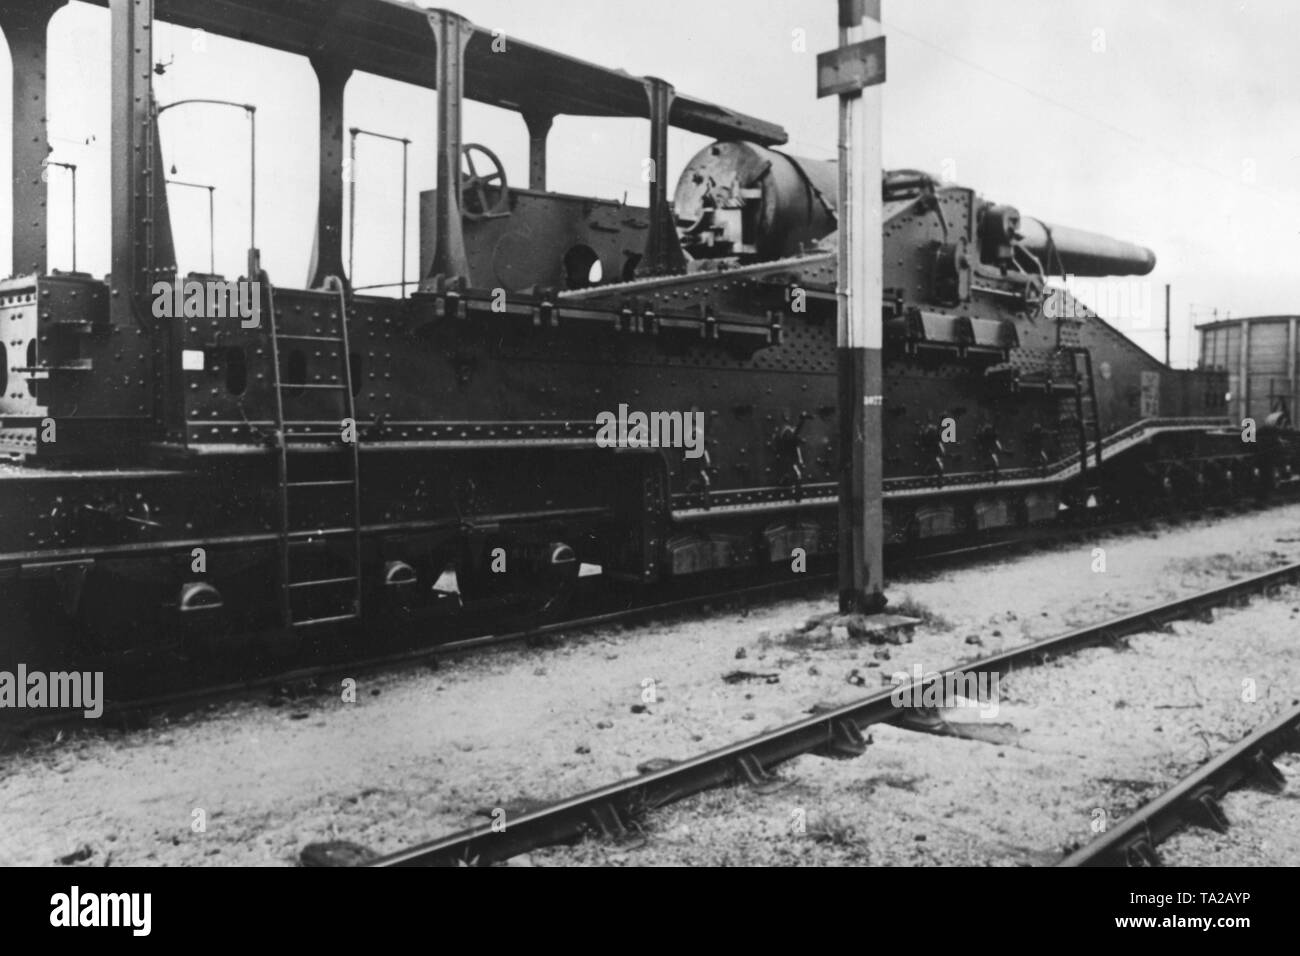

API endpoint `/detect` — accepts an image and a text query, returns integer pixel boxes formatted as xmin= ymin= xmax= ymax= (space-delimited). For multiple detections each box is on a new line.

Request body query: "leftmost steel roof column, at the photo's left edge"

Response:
xmin=0 ymin=0 xmax=66 ymax=276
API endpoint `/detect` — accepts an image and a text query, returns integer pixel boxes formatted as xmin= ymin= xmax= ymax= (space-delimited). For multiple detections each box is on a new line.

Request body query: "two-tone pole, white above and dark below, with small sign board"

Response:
xmin=818 ymin=0 xmax=885 ymax=614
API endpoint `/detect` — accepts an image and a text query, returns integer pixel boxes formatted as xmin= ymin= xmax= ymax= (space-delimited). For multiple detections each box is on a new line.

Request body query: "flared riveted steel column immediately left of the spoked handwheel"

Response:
xmin=428 ymin=10 xmax=473 ymax=281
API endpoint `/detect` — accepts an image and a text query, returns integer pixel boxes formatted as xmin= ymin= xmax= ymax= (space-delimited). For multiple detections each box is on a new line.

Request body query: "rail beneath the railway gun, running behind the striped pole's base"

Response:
xmin=0 ymin=494 xmax=1300 ymax=747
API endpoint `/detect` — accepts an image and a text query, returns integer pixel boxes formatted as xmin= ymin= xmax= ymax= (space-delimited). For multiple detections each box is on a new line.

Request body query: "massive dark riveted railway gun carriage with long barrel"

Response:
xmin=0 ymin=0 xmax=1291 ymax=661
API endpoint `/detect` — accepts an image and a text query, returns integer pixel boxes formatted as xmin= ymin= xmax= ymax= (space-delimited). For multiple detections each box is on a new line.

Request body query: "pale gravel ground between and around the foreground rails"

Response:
xmin=0 ymin=506 xmax=1300 ymax=866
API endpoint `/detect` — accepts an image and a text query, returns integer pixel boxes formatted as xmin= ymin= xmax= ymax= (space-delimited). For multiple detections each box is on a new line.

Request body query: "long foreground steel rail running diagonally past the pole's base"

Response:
xmin=372 ymin=563 xmax=1300 ymax=866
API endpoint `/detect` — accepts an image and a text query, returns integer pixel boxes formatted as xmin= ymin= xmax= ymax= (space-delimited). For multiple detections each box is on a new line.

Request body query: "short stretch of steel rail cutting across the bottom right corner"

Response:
xmin=1057 ymin=706 xmax=1300 ymax=866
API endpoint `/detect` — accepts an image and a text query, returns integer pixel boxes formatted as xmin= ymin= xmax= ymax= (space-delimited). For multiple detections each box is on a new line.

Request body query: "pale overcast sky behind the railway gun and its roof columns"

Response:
xmin=0 ymin=0 xmax=1300 ymax=365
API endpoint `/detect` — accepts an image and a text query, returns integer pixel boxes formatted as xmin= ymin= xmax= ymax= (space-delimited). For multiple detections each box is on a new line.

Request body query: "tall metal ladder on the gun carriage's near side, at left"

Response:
xmin=264 ymin=276 xmax=361 ymax=628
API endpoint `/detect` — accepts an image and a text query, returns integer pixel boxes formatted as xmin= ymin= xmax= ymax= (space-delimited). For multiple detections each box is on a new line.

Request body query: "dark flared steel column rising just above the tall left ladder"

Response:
xmin=307 ymin=56 xmax=352 ymax=289
